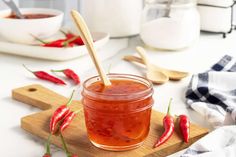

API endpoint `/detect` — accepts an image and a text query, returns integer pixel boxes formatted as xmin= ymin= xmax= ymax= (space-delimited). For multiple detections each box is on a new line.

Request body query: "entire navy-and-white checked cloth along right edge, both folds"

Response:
xmin=181 ymin=55 xmax=236 ymax=157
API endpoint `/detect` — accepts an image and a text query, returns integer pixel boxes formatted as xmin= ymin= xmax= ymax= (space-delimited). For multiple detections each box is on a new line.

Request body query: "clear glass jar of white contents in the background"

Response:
xmin=140 ymin=0 xmax=200 ymax=50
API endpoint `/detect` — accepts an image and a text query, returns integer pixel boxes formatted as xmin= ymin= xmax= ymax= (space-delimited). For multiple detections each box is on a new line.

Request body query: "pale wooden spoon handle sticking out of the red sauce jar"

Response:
xmin=71 ymin=10 xmax=111 ymax=86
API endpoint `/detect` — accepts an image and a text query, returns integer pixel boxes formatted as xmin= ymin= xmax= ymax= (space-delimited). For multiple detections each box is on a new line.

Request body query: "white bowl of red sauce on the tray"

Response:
xmin=0 ymin=8 xmax=64 ymax=44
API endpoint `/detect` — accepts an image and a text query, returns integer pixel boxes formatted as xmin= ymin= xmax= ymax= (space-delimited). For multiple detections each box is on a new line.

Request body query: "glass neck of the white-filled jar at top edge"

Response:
xmin=145 ymin=0 xmax=197 ymax=9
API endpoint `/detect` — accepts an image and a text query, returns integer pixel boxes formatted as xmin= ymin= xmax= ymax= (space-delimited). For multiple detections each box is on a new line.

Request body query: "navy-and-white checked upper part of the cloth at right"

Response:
xmin=186 ymin=55 xmax=236 ymax=127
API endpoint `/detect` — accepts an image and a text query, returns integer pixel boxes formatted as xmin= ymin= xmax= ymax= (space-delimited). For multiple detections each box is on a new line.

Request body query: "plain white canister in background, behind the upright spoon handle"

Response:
xmin=80 ymin=0 xmax=143 ymax=37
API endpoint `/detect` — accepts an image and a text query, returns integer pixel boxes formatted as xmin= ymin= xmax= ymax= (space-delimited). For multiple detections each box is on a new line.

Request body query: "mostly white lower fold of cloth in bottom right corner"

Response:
xmin=180 ymin=125 xmax=236 ymax=157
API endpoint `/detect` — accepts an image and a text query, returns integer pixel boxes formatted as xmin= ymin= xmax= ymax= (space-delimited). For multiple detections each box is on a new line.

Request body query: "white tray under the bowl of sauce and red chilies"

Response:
xmin=0 ymin=32 xmax=109 ymax=61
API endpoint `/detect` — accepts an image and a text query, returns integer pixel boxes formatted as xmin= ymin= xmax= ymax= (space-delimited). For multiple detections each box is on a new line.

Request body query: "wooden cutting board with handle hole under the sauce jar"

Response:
xmin=12 ymin=84 xmax=208 ymax=157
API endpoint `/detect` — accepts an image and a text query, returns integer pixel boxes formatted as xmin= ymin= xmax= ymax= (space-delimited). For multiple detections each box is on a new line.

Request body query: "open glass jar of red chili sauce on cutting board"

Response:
xmin=82 ymin=74 xmax=153 ymax=151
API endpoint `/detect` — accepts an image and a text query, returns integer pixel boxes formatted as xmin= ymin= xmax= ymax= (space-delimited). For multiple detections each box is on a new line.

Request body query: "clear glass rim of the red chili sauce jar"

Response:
xmin=83 ymin=73 xmax=153 ymax=100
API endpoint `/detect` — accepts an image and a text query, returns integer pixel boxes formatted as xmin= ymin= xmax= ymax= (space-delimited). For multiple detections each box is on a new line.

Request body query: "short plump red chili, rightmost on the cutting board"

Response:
xmin=179 ymin=115 xmax=190 ymax=143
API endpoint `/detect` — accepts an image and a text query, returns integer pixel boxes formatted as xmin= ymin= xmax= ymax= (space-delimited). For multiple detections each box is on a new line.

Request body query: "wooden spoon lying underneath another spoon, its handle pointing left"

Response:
xmin=124 ymin=55 xmax=189 ymax=81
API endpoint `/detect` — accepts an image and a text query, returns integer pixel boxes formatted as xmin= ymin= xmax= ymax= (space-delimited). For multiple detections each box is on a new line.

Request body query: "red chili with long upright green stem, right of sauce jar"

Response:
xmin=153 ymin=99 xmax=174 ymax=148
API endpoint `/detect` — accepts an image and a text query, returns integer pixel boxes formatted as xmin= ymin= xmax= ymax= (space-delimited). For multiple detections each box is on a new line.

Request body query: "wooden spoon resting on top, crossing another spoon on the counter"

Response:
xmin=136 ymin=47 xmax=169 ymax=84
